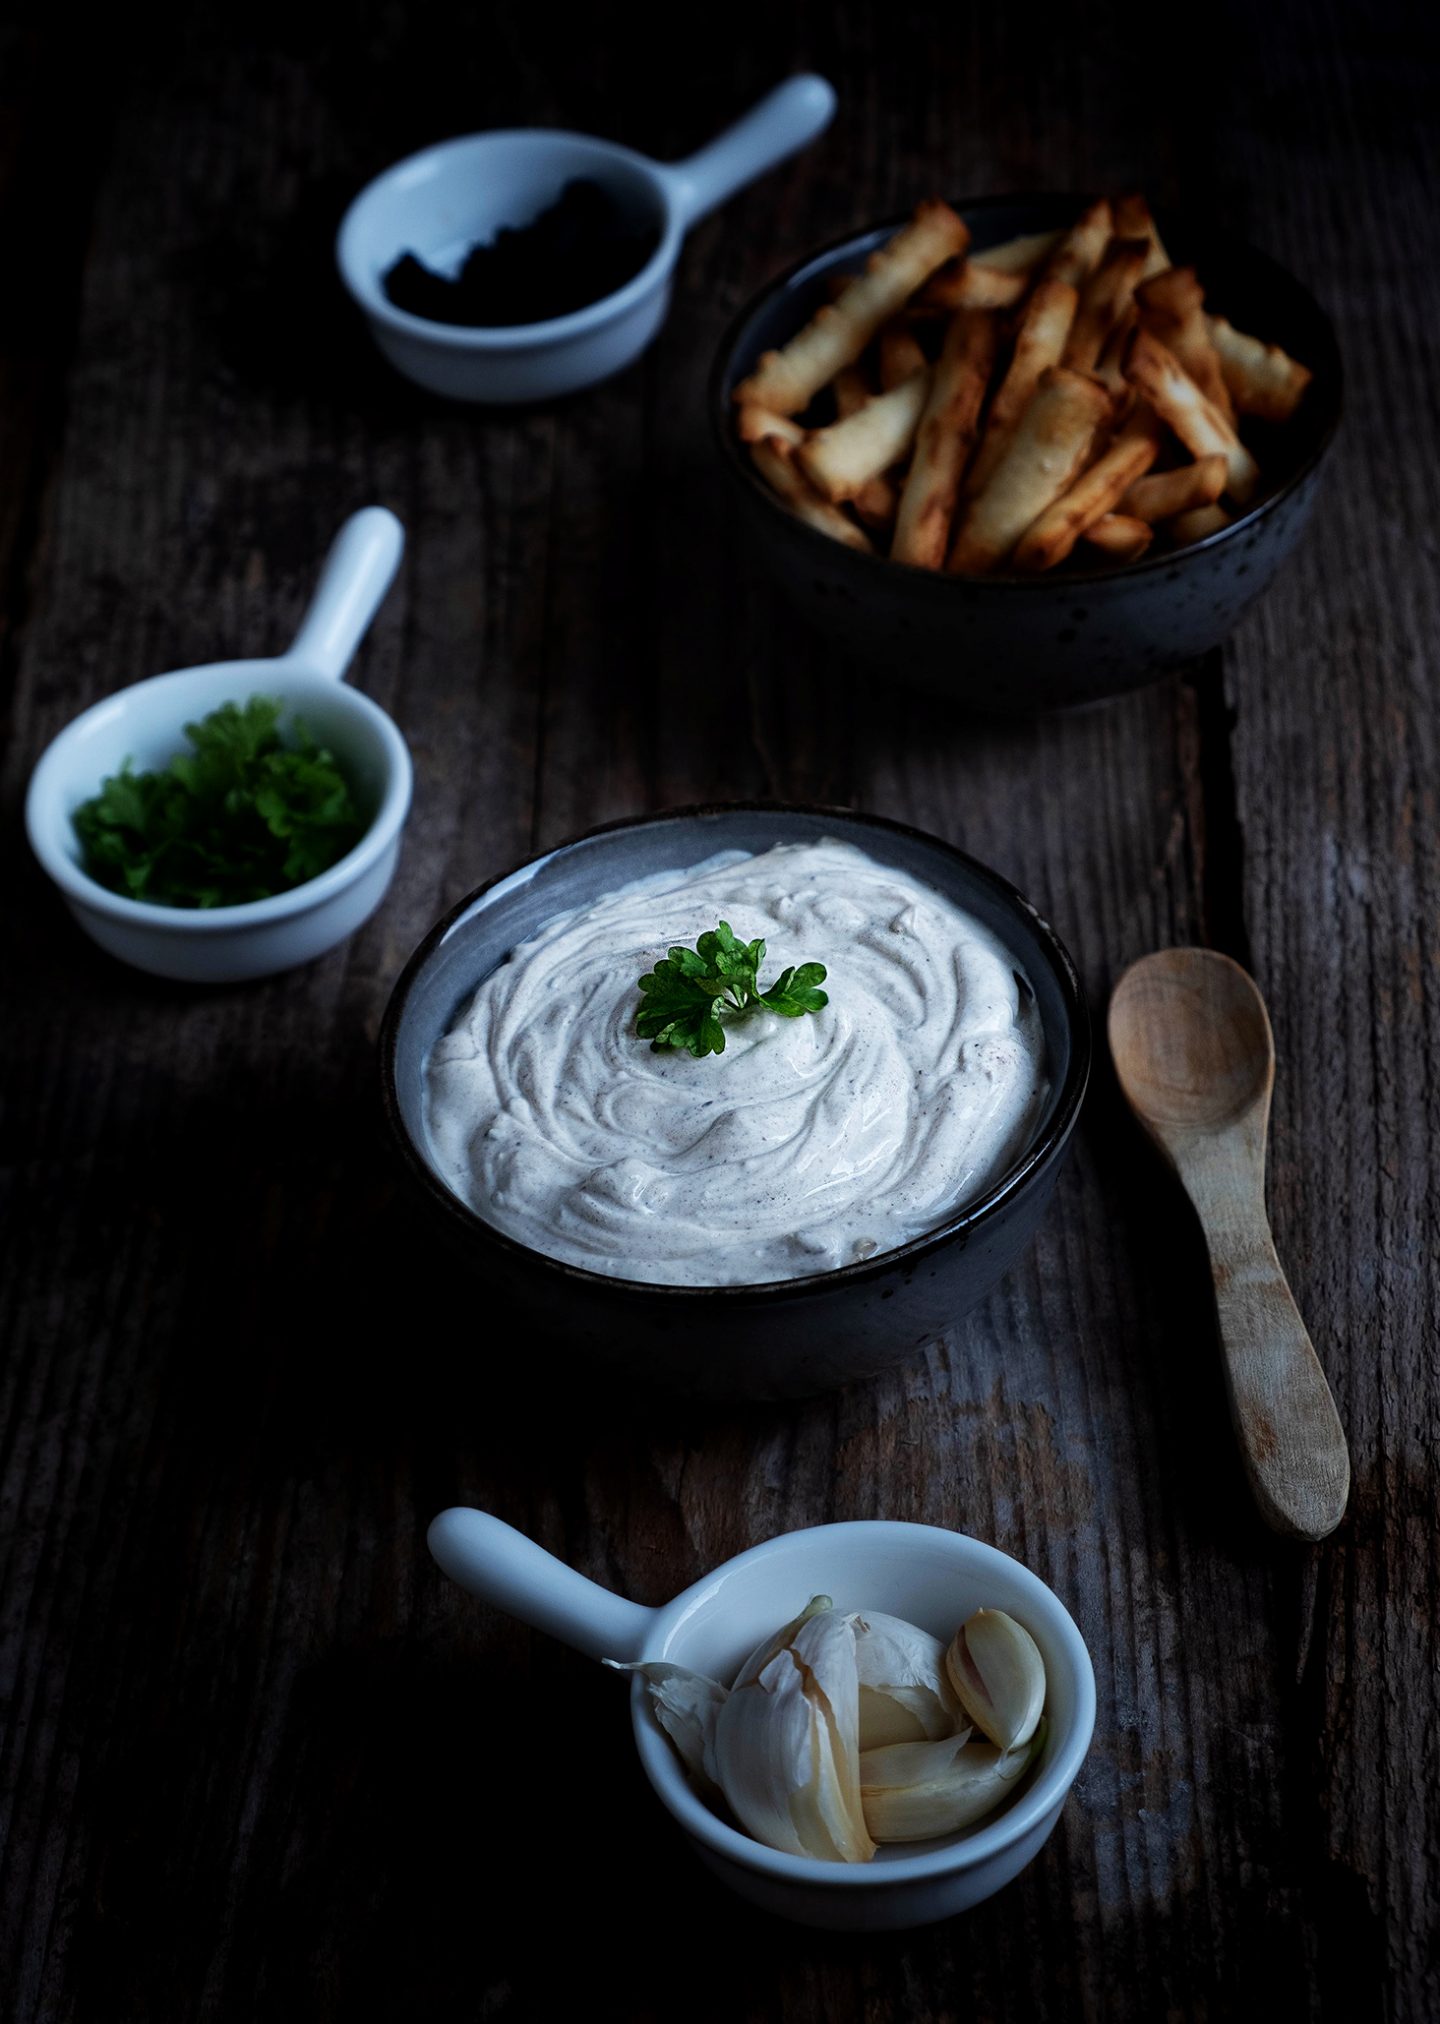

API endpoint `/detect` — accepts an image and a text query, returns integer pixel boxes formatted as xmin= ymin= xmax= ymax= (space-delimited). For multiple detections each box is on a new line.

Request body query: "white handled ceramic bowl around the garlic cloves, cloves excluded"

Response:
xmin=429 ymin=1506 xmax=1096 ymax=1931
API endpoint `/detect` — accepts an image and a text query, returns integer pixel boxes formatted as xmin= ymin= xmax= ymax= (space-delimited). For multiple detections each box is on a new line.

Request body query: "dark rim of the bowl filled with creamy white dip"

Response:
xmin=379 ymin=799 xmax=1094 ymax=1308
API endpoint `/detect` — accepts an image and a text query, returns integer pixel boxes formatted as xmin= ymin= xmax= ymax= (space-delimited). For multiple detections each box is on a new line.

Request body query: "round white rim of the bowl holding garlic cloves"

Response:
xmin=630 ymin=1518 xmax=1096 ymax=1890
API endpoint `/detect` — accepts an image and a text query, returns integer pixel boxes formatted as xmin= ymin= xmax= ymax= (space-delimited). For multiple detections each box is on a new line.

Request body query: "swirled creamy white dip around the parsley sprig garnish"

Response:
xmin=425 ymin=842 xmax=1045 ymax=1285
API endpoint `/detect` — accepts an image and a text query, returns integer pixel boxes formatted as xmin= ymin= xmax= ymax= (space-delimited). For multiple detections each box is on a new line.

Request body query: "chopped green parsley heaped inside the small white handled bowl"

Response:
xmin=75 ymin=696 xmax=367 ymax=907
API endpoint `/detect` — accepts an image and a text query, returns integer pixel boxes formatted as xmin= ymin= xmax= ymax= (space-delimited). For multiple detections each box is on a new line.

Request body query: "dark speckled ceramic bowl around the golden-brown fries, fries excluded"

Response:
xmin=709 ymin=196 xmax=1343 ymax=710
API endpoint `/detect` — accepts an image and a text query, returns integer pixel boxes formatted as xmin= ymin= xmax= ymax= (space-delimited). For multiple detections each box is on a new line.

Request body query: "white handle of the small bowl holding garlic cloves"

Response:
xmin=429 ymin=1504 xmax=658 ymax=1660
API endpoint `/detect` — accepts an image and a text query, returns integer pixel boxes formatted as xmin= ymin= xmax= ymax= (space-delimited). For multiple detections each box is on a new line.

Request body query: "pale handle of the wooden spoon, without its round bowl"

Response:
xmin=1181 ymin=1160 xmax=1351 ymax=1540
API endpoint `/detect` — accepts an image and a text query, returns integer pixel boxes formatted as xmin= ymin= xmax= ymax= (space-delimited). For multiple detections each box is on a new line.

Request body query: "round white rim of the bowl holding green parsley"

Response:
xmin=24 ymin=658 xmax=415 ymax=937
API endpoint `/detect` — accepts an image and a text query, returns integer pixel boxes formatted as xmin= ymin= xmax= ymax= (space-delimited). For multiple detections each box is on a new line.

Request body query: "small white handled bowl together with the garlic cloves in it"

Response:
xmin=429 ymin=1508 xmax=1096 ymax=1931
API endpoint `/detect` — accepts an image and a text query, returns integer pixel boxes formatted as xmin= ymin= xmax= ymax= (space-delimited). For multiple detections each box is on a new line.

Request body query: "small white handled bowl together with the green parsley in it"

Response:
xmin=26 ymin=506 xmax=411 ymax=984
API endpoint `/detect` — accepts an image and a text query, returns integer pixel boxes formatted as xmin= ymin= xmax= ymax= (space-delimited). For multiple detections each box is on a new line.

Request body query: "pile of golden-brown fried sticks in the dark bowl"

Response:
xmin=735 ymin=194 xmax=1310 ymax=577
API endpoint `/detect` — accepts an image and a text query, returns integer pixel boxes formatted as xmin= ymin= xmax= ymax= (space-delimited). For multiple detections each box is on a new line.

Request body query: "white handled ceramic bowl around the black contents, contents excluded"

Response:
xmin=336 ymin=75 xmax=834 ymax=405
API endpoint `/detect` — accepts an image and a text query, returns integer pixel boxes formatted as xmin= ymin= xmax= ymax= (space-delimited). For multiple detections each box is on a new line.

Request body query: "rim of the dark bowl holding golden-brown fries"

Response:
xmin=705 ymin=190 xmax=1345 ymax=597
